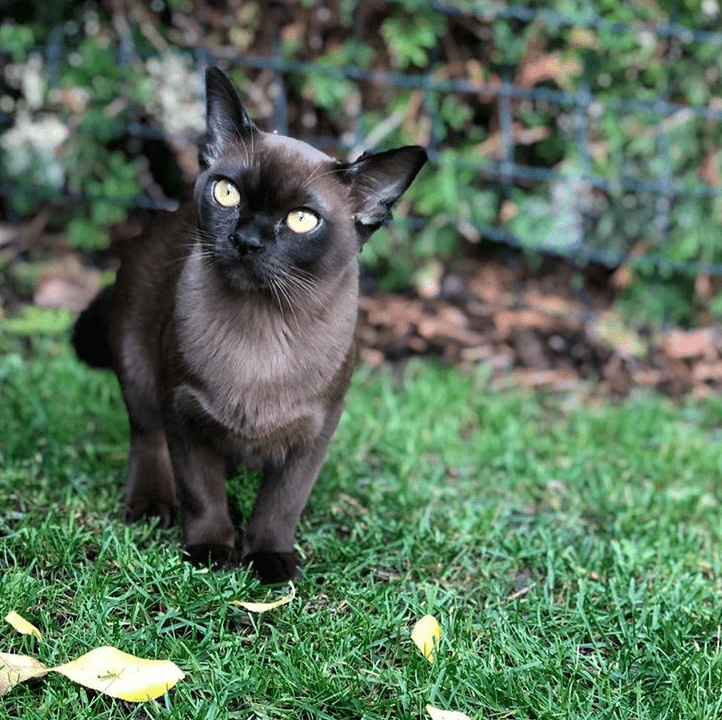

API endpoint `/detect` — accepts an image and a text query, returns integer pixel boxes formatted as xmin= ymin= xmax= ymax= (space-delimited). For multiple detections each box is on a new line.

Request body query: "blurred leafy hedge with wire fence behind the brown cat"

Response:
xmin=0 ymin=0 xmax=722 ymax=325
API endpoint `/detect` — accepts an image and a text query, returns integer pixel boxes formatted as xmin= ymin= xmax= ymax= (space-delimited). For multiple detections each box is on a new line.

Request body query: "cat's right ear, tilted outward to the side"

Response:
xmin=342 ymin=145 xmax=427 ymax=242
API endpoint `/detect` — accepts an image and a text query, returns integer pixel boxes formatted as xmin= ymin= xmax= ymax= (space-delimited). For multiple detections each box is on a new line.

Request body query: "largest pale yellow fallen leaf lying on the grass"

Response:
xmin=53 ymin=647 xmax=185 ymax=702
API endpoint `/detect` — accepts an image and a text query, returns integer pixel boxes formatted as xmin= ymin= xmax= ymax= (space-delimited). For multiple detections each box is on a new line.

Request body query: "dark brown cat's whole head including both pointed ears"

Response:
xmin=195 ymin=68 xmax=426 ymax=299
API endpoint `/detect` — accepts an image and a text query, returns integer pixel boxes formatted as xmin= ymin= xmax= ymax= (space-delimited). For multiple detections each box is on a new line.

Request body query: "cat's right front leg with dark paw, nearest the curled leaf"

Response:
xmin=241 ymin=405 xmax=342 ymax=583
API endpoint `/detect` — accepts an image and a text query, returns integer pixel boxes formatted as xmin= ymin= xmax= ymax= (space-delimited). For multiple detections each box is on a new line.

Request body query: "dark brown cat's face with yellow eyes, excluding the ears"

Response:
xmin=196 ymin=130 xmax=358 ymax=291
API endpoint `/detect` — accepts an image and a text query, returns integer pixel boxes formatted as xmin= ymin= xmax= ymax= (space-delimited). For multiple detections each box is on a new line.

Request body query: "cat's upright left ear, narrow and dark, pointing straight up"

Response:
xmin=199 ymin=67 xmax=256 ymax=167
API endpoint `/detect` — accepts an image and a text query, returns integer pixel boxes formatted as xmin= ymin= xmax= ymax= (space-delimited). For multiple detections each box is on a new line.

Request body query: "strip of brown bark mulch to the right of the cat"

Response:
xmin=360 ymin=260 xmax=722 ymax=398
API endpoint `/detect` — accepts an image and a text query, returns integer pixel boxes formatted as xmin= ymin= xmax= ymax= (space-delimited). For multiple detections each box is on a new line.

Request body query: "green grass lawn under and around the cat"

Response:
xmin=0 ymin=341 xmax=722 ymax=720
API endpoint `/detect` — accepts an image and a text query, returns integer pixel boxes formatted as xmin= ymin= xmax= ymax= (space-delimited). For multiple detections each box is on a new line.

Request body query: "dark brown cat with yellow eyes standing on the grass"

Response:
xmin=72 ymin=68 xmax=427 ymax=583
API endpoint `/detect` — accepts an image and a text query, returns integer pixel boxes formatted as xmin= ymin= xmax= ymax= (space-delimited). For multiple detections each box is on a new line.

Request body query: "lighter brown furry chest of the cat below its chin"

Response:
xmin=175 ymin=253 xmax=356 ymax=442
